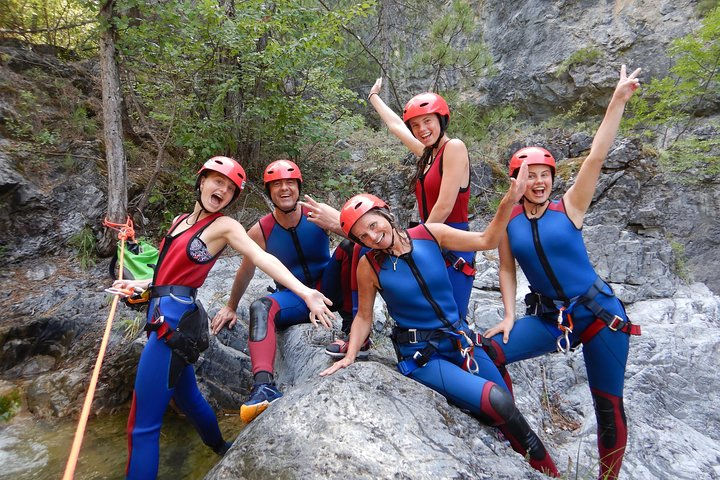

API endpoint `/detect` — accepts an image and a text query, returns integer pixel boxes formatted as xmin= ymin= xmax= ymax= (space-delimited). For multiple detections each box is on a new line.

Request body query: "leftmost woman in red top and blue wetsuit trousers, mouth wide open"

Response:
xmin=113 ymin=157 xmax=332 ymax=480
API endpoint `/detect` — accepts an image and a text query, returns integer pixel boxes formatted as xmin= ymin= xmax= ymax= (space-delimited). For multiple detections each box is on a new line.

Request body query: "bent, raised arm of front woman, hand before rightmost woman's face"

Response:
xmin=426 ymin=162 xmax=528 ymax=252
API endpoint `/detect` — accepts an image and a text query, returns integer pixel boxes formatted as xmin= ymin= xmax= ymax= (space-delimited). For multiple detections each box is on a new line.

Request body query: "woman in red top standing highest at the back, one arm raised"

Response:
xmin=368 ymin=78 xmax=475 ymax=318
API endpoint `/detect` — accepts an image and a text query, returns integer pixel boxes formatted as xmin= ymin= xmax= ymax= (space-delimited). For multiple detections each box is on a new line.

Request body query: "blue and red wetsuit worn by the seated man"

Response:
xmin=248 ymin=210 xmax=352 ymax=374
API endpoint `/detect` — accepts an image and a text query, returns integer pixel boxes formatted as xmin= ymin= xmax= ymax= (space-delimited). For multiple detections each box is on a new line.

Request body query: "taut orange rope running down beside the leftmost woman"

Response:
xmin=63 ymin=217 xmax=135 ymax=480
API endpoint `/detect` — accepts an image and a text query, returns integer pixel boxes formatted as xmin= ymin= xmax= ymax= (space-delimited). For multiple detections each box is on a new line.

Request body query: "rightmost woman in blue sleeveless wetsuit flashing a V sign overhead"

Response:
xmin=484 ymin=65 xmax=640 ymax=479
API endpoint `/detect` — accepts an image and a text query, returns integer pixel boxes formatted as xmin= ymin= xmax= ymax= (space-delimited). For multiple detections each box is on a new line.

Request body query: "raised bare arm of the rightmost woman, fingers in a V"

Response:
xmin=563 ymin=65 xmax=640 ymax=228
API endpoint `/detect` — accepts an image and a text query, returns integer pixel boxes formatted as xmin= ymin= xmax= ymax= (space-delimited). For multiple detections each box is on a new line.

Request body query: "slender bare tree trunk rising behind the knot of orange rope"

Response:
xmin=98 ymin=0 xmax=127 ymax=255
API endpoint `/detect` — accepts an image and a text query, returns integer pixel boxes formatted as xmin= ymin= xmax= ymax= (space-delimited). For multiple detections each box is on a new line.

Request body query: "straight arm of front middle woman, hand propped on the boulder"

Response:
xmin=320 ymin=257 xmax=378 ymax=377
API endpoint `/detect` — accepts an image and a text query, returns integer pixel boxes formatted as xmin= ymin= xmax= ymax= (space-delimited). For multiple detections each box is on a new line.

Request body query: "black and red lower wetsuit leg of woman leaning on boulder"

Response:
xmin=480 ymin=382 xmax=560 ymax=477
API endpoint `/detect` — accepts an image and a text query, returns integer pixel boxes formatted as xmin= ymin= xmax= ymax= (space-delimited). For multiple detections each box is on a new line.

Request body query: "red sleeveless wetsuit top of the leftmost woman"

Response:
xmin=153 ymin=212 xmax=225 ymax=288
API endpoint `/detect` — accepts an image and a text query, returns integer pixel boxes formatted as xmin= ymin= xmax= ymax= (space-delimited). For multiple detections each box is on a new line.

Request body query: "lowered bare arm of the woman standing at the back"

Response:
xmin=425 ymin=139 xmax=470 ymax=223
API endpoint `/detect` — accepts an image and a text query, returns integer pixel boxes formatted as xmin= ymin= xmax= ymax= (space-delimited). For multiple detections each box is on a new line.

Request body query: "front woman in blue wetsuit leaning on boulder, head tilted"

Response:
xmin=320 ymin=176 xmax=558 ymax=476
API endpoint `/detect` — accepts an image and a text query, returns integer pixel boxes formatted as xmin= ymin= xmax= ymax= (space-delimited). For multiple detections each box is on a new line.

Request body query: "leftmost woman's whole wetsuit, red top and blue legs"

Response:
xmin=125 ymin=213 xmax=227 ymax=480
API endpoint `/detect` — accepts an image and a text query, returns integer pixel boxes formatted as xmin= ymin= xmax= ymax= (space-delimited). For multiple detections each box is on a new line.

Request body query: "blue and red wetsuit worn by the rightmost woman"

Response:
xmin=492 ymin=200 xmax=629 ymax=478
